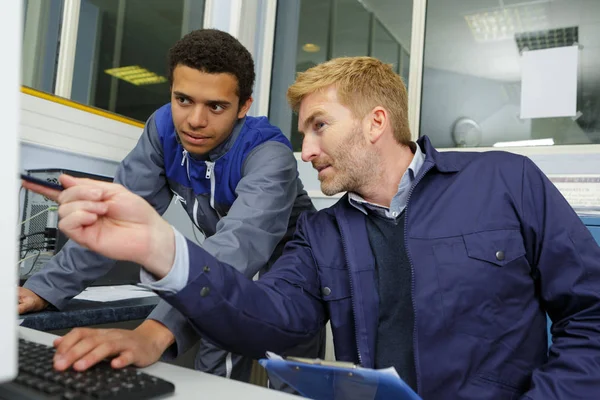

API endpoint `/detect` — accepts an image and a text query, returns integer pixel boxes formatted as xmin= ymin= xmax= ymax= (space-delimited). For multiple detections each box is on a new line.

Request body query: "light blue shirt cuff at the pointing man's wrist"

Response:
xmin=139 ymin=227 xmax=190 ymax=294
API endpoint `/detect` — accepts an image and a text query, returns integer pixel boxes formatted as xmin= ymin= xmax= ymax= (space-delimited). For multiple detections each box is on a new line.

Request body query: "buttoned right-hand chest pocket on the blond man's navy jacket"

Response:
xmin=433 ymin=230 xmax=533 ymax=339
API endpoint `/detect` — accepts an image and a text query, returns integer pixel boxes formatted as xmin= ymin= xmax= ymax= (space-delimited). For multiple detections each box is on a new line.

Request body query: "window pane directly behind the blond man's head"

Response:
xmin=269 ymin=0 xmax=412 ymax=151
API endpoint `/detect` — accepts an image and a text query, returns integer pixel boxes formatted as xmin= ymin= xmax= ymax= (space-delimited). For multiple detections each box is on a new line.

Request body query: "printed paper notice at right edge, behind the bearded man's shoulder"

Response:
xmin=548 ymin=175 xmax=600 ymax=214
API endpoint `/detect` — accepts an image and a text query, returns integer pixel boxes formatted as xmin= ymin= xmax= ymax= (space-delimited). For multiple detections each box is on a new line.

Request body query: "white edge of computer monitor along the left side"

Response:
xmin=0 ymin=1 xmax=23 ymax=382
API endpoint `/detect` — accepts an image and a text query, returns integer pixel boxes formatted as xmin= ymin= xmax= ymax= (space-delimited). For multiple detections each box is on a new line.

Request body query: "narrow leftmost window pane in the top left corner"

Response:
xmin=21 ymin=0 xmax=63 ymax=93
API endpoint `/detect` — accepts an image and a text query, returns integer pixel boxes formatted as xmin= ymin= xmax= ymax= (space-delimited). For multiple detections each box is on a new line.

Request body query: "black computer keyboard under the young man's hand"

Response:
xmin=0 ymin=339 xmax=175 ymax=400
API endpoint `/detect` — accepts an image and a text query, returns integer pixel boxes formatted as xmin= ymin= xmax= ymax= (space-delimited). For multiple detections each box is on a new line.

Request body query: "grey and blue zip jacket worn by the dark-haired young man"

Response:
xmin=24 ymin=104 xmax=314 ymax=375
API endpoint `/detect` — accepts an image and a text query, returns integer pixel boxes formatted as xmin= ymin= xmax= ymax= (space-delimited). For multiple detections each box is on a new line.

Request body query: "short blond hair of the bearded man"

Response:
xmin=287 ymin=57 xmax=411 ymax=144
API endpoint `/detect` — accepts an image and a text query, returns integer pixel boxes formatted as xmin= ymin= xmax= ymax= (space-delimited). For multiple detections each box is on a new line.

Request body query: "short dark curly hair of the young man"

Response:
xmin=167 ymin=29 xmax=255 ymax=105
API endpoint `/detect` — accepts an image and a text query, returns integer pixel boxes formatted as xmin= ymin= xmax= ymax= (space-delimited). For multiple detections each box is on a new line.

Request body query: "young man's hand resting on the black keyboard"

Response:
xmin=54 ymin=320 xmax=174 ymax=371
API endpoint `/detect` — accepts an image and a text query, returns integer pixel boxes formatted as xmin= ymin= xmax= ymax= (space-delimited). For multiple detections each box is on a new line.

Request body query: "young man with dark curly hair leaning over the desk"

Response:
xmin=19 ymin=29 xmax=324 ymax=388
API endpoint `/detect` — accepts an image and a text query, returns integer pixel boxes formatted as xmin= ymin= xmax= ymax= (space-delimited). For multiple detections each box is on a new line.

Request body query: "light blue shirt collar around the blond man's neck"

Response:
xmin=348 ymin=145 xmax=425 ymax=220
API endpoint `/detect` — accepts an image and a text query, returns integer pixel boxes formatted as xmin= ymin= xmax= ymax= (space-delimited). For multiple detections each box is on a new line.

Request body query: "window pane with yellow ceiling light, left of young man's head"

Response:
xmin=71 ymin=0 xmax=204 ymax=121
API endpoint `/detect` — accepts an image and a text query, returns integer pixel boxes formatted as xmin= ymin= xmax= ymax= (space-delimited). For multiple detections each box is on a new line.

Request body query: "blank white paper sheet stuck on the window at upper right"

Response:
xmin=521 ymin=46 xmax=579 ymax=118
